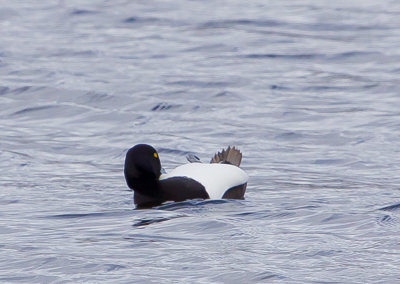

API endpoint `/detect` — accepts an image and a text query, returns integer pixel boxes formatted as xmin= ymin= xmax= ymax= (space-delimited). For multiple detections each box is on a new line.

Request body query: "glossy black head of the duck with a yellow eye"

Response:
xmin=124 ymin=144 xmax=161 ymax=196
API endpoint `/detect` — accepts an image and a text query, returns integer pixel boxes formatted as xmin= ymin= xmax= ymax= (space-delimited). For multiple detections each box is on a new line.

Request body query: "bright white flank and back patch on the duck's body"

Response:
xmin=160 ymin=163 xmax=249 ymax=199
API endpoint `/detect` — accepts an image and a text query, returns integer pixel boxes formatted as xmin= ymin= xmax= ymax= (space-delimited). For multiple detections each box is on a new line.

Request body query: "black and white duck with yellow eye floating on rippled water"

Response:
xmin=124 ymin=144 xmax=248 ymax=209
